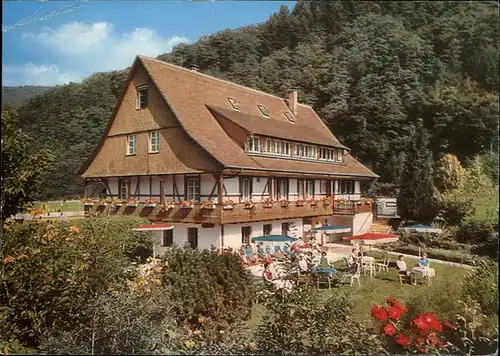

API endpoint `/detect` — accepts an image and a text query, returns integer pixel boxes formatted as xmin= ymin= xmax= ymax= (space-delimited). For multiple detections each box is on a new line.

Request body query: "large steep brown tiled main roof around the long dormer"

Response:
xmin=86 ymin=56 xmax=376 ymax=177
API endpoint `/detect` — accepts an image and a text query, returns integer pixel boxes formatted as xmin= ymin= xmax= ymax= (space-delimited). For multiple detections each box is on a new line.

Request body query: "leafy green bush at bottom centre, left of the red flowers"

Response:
xmin=254 ymin=285 xmax=387 ymax=355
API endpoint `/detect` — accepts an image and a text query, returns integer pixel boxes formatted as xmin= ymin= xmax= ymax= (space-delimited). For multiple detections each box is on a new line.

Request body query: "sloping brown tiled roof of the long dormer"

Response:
xmin=207 ymin=105 xmax=347 ymax=148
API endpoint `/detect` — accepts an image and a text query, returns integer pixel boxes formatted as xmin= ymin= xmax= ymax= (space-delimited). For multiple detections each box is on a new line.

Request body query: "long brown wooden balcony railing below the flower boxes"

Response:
xmin=86 ymin=201 xmax=372 ymax=224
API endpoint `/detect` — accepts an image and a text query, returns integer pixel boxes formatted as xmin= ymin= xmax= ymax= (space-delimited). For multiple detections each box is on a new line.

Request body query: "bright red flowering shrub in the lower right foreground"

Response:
xmin=371 ymin=298 xmax=456 ymax=353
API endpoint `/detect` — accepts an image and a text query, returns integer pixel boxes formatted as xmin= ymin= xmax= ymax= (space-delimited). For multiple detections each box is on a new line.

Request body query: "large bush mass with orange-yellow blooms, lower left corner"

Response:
xmin=0 ymin=216 xmax=152 ymax=347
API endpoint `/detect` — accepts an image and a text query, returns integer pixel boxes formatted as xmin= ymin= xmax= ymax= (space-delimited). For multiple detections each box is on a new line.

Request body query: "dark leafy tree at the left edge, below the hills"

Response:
xmin=0 ymin=110 xmax=54 ymax=223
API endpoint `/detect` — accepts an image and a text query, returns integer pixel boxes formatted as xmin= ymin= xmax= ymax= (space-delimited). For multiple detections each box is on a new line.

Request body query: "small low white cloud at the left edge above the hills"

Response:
xmin=2 ymin=63 xmax=82 ymax=86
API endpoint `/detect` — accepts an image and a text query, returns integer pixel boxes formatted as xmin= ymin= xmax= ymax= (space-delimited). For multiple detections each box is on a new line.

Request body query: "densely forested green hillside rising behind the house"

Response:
xmin=13 ymin=1 xmax=499 ymax=198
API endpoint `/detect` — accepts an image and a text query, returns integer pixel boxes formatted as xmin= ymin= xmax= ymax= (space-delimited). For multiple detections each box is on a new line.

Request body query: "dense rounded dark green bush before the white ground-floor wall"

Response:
xmin=162 ymin=248 xmax=255 ymax=331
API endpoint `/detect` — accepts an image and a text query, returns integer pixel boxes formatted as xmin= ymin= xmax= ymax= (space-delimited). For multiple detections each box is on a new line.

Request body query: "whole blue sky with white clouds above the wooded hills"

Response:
xmin=2 ymin=1 xmax=295 ymax=86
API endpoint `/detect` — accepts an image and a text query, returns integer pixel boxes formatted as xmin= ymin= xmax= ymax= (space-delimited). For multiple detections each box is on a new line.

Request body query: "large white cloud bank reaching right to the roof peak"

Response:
xmin=9 ymin=22 xmax=189 ymax=85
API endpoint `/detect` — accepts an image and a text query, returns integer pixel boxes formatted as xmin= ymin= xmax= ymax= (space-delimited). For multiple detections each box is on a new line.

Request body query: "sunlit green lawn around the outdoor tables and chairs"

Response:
xmin=248 ymin=252 xmax=468 ymax=329
